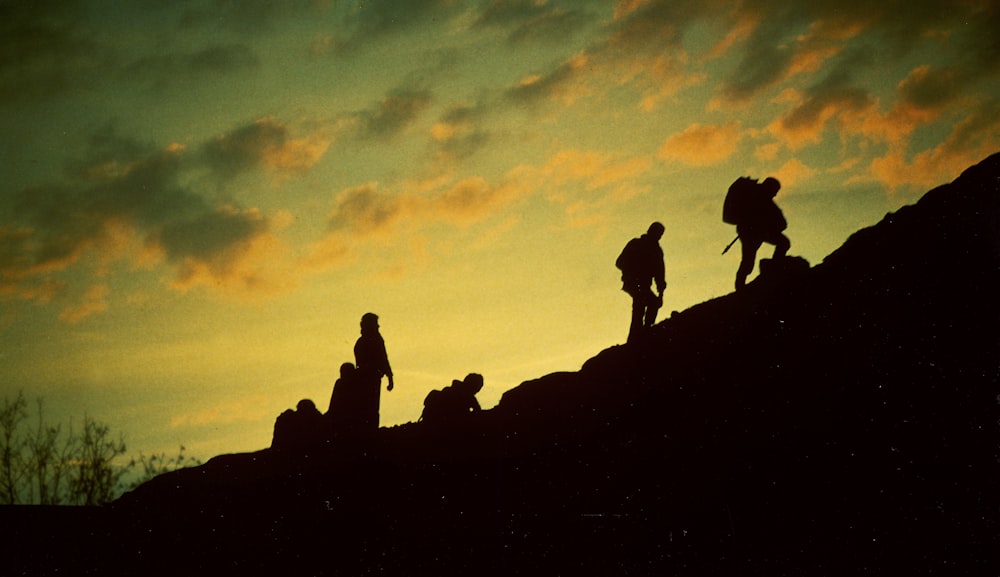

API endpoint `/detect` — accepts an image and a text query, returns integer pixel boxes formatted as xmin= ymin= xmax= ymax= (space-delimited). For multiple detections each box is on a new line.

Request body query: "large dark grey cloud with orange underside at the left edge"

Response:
xmin=0 ymin=119 xmax=316 ymax=322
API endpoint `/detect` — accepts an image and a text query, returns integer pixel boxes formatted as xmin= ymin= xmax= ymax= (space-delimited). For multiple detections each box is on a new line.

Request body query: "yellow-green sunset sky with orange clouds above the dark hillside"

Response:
xmin=0 ymin=0 xmax=1000 ymax=460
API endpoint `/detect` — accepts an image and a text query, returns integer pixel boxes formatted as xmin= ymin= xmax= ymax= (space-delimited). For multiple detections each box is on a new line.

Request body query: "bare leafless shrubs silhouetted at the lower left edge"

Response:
xmin=0 ymin=392 xmax=200 ymax=505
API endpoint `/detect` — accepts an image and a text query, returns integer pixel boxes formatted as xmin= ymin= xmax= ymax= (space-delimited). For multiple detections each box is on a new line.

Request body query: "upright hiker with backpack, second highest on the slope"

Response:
xmin=615 ymin=222 xmax=667 ymax=342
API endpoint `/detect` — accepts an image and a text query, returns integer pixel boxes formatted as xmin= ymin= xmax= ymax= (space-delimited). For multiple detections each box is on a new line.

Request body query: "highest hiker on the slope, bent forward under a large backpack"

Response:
xmin=722 ymin=176 xmax=792 ymax=290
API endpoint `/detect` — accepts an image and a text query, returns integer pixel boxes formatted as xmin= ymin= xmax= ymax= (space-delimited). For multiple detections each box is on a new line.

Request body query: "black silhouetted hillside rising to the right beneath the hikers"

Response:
xmin=9 ymin=155 xmax=1000 ymax=575
